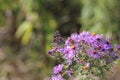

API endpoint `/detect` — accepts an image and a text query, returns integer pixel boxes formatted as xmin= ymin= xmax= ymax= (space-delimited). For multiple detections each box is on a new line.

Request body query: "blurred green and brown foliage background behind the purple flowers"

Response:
xmin=0 ymin=0 xmax=120 ymax=80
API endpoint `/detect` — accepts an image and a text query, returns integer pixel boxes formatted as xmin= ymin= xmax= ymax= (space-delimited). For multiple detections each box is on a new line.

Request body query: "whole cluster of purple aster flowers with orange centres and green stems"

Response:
xmin=48 ymin=31 xmax=120 ymax=80
